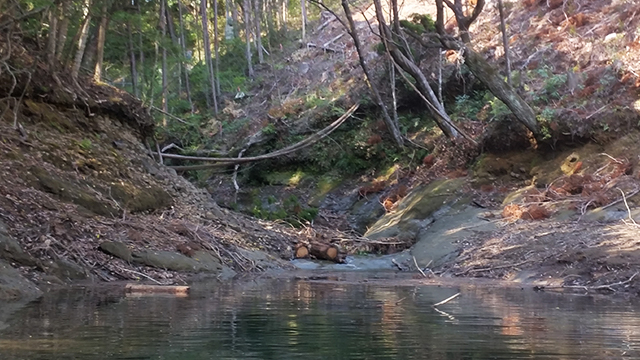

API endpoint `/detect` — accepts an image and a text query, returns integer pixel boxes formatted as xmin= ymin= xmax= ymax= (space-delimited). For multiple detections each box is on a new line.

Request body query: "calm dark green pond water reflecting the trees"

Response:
xmin=0 ymin=274 xmax=640 ymax=360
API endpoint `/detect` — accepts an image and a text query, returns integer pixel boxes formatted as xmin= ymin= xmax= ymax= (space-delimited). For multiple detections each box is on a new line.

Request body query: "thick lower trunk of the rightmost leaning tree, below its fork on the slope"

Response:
xmin=464 ymin=46 xmax=540 ymax=136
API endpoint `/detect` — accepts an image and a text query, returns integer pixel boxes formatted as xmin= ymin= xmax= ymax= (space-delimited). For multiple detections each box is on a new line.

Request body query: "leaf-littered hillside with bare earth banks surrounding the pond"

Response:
xmin=0 ymin=1 xmax=640 ymax=297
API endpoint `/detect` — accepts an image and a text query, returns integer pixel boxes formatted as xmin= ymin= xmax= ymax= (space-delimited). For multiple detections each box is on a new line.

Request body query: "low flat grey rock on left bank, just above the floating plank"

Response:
xmin=132 ymin=250 xmax=223 ymax=273
